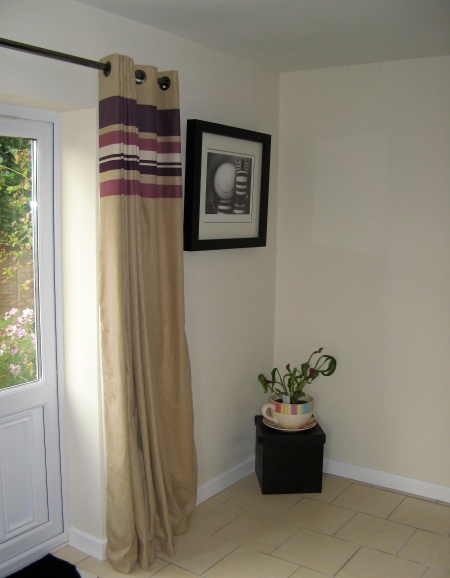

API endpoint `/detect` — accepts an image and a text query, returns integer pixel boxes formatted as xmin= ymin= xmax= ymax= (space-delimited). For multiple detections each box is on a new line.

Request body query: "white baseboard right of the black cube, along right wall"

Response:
xmin=323 ymin=458 xmax=450 ymax=502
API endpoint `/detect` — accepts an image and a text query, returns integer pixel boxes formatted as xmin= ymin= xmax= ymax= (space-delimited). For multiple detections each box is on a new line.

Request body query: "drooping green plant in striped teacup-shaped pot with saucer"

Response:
xmin=258 ymin=347 xmax=337 ymax=430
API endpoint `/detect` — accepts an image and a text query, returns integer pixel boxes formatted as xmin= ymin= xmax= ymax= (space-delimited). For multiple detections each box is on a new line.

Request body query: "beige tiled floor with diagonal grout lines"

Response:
xmin=56 ymin=474 xmax=450 ymax=578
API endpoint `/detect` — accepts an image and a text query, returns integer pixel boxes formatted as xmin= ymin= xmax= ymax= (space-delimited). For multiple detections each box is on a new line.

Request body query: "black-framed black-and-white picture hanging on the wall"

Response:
xmin=184 ymin=120 xmax=271 ymax=251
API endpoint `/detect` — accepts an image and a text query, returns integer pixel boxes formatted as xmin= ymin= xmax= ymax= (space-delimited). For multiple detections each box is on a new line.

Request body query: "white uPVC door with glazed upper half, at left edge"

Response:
xmin=0 ymin=108 xmax=64 ymax=576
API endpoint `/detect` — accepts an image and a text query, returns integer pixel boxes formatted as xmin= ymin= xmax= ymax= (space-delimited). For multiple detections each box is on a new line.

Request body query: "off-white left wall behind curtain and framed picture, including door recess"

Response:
xmin=0 ymin=0 xmax=279 ymax=548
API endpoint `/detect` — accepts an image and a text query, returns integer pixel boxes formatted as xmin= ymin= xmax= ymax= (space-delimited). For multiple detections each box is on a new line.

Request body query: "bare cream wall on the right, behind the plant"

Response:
xmin=275 ymin=58 xmax=450 ymax=495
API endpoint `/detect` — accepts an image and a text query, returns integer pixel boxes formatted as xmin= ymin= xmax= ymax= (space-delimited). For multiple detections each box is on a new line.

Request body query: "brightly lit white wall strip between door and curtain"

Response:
xmin=61 ymin=109 xmax=106 ymax=555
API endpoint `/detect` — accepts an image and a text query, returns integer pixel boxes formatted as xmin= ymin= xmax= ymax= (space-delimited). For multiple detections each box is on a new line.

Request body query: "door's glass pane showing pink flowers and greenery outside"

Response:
xmin=0 ymin=136 xmax=39 ymax=389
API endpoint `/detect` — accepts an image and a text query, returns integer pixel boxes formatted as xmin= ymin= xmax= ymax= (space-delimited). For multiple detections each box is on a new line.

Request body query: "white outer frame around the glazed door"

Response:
xmin=0 ymin=103 xmax=70 ymax=577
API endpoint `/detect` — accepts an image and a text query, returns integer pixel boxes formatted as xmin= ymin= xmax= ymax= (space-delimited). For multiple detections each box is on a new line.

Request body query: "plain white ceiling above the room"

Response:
xmin=77 ymin=0 xmax=450 ymax=72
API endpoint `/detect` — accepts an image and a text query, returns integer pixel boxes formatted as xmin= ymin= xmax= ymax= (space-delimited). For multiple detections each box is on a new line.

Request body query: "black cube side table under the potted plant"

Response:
xmin=255 ymin=415 xmax=326 ymax=494
